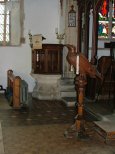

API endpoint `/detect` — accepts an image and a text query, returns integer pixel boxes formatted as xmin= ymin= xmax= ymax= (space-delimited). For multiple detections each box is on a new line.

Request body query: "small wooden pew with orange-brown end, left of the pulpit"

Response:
xmin=6 ymin=70 xmax=28 ymax=108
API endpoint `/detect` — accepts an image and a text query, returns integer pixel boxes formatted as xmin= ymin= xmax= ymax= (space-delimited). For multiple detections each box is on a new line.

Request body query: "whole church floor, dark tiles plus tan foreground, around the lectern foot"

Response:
xmin=0 ymin=95 xmax=115 ymax=154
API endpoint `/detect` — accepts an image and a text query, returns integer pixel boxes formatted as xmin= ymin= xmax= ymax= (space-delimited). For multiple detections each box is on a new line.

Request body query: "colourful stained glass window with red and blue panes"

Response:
xmin=98 ymin=0 xmax=115 ymax=38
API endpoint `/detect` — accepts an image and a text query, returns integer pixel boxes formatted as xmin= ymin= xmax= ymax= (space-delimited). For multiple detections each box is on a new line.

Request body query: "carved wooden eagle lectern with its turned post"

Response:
xmin=65 ymin=45 xmax=100 ymax=139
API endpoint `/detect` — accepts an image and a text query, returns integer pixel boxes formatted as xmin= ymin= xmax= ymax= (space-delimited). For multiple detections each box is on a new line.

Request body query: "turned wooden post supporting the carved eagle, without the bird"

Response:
xmin=75 ymin=74 xmax=87 ymax=137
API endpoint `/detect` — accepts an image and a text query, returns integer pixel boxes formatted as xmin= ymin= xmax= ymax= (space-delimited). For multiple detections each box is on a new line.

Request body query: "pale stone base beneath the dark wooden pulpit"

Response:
xmin=31 ymin=74 xmax=61 ymax=100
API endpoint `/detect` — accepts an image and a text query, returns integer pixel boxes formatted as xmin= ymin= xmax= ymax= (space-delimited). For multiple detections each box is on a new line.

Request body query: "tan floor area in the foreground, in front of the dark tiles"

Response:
xmin=3 ymin=124 xmax=115 ymax=154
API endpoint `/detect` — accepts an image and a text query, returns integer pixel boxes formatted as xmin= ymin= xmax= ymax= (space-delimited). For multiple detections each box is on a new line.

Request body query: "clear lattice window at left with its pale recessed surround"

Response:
xmin=0 ymin=0 xmax=24 ymax=46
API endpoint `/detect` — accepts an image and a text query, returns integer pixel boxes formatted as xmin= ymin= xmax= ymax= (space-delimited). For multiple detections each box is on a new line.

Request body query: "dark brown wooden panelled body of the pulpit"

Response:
xmin=32 ymin=44 xmax=63 ymax=74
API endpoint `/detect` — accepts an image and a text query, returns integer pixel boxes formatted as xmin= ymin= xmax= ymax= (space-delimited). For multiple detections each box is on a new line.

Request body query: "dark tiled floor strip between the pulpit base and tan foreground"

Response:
xmin=0 ymin=99 xmax=75 ymax=127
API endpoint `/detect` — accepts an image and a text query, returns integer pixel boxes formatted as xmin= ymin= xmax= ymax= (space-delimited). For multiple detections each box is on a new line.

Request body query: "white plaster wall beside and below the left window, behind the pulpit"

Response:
xmin=0 ymin=0 xmax=59 ymax=92
